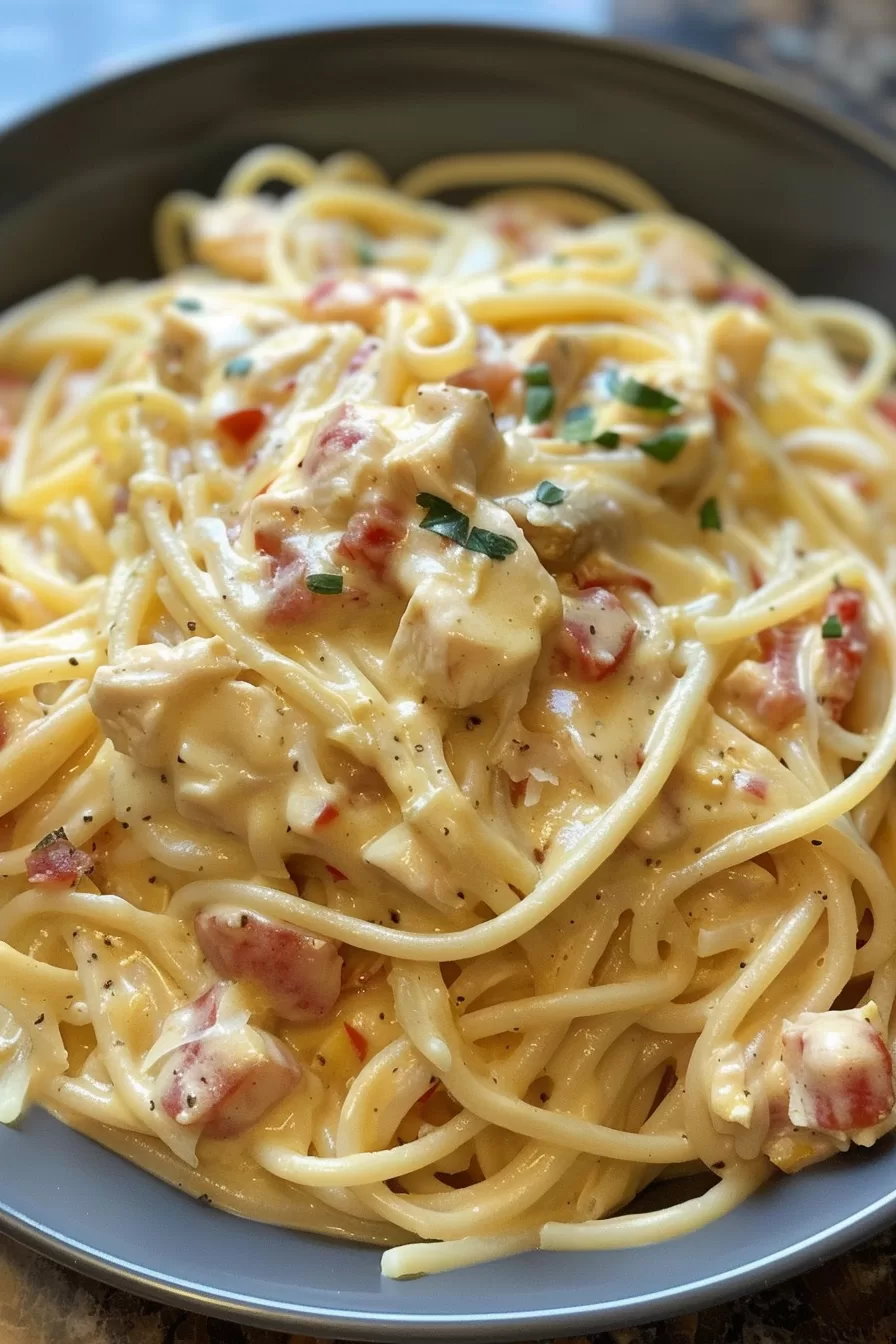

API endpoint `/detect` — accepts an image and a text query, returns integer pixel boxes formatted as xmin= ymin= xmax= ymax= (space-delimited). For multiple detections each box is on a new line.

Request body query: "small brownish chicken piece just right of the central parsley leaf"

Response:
xmin=502 ymin=481 xmax=623 ymax=569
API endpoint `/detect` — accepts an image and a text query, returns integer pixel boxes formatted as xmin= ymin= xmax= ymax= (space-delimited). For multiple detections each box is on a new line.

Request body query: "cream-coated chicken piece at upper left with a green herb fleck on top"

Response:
xmin=153 ymin=292 xmax=287 ymax=396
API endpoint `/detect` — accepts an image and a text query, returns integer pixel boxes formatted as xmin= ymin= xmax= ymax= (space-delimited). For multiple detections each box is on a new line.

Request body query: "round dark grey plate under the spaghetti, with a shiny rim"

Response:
xmin=0 ymin=27 xmax=896 ymax=1340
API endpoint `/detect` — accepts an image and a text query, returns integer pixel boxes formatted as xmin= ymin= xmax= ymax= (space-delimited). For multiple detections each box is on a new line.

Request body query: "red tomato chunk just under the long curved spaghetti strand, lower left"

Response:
xmin=195 ymin=906 xmax=343 ymax=1021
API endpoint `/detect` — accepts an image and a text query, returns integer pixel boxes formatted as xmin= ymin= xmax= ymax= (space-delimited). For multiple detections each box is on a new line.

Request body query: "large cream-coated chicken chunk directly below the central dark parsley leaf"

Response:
xmin=390 ymin=500 xmax=560 ymax=708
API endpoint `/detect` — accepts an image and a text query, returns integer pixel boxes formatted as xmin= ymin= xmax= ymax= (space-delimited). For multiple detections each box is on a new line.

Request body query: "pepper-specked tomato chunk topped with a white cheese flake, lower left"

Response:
xmin=156 ymin=981 xmax=302 ymax=1138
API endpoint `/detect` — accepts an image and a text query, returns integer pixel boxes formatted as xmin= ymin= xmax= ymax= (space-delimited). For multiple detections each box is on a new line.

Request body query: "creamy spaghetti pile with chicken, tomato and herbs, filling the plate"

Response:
xmin=0 ymin=146 xmax=896 ymax=1277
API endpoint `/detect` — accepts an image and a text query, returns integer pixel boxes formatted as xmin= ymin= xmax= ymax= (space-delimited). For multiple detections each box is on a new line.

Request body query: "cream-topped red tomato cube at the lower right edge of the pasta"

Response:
xmin=782 ymin=1005 xmax=896 ymax=1134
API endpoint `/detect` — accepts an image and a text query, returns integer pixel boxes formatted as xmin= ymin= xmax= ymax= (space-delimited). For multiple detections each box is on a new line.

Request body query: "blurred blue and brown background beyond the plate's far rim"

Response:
xmin=0 ymin=0 xmax=896 ymax=134
